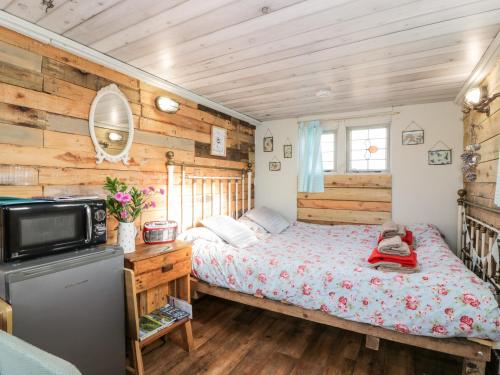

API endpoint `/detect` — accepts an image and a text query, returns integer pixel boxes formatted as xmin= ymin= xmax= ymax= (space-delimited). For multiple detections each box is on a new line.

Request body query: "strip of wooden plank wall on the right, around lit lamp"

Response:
xmin=464 ymin=59 xmax=500 ymax=228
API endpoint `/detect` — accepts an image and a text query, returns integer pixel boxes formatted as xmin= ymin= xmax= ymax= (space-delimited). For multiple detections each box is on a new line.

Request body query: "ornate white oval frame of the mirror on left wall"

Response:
xmin=89 ymin=83 xmax=134 ymax=165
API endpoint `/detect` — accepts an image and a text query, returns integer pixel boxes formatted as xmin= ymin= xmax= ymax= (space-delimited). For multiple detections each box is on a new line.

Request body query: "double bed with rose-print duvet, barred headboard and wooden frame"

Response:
xmin=167 ymin=153 xmax=500 ymax=374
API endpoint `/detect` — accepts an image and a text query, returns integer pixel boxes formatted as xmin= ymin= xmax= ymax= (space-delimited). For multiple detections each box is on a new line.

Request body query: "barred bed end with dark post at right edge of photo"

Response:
xmin=457 ymin=189 xmax=500 ymax=296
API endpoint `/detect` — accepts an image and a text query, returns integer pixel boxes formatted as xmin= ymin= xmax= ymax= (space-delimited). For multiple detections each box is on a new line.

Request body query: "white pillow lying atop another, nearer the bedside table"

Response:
xmin=201 ymin=216 xmax=258 ymax=248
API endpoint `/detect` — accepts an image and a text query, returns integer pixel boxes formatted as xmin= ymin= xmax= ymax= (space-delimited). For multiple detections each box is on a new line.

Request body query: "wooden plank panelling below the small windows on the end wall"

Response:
xmin=297 ymin=174 xmax=392 ymax=224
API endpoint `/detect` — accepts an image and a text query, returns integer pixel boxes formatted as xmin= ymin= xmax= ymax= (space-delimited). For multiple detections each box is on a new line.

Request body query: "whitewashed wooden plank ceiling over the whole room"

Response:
xmin=0 ymin=0 xmax=500 ymax=120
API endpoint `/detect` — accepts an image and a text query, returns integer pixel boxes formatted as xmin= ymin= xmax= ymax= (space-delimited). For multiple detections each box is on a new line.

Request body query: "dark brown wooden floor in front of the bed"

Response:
xmin=144 ymin=296 xmax=461 ymax=375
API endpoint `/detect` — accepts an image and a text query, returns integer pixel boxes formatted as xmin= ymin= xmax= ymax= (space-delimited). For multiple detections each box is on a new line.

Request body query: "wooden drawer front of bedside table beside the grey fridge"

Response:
xmin=135 ymin=258 xmax=191 ymax=293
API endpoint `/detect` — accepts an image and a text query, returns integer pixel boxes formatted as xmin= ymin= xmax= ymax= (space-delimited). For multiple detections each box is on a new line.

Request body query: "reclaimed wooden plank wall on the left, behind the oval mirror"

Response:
xmin=0 ymin=28 xmax=255 ymax=241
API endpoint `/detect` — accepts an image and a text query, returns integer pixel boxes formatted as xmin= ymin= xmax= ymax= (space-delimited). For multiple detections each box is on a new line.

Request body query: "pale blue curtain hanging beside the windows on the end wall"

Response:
xmin=299 ymin=120 xmax=325 ymax=193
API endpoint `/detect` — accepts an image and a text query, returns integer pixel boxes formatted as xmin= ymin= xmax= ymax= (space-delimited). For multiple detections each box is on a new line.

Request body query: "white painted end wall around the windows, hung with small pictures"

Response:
xmin=255 ymin=102 xmax=463 ymax=248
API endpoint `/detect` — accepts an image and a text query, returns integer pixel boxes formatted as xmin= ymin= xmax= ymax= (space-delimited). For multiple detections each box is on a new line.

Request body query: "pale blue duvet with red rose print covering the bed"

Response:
xmin=193 ymin=222 xmax=500 ymax=341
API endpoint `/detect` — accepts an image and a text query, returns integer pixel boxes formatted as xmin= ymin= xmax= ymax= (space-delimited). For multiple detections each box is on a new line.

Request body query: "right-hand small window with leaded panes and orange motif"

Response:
xmin=347 ymin=125 xmax=389 ymax=172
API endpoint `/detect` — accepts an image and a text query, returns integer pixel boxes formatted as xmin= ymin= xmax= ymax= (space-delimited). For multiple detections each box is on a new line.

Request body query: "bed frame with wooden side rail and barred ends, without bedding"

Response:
xmin=167 ymin=152 xmax=500 ymax=375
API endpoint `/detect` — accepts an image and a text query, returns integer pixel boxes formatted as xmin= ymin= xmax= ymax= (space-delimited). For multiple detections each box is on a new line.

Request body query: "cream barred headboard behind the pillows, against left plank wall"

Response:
xmin=167 ymin=151 xmax=253 ymax=231
